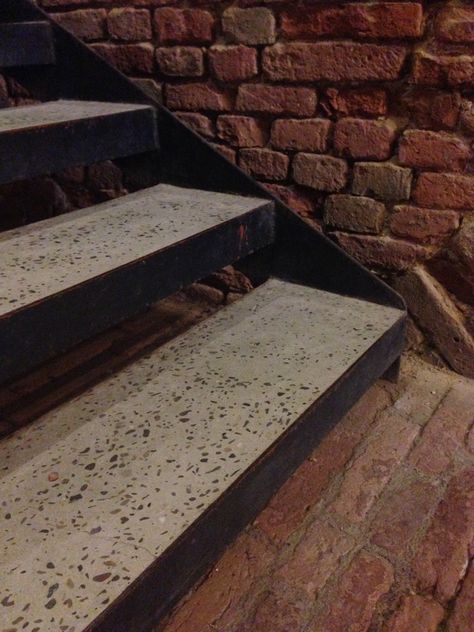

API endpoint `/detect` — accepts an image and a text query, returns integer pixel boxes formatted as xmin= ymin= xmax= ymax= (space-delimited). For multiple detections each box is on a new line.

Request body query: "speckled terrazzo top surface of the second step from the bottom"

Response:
xmin=0 ymin=184 xmax=271 ymax=318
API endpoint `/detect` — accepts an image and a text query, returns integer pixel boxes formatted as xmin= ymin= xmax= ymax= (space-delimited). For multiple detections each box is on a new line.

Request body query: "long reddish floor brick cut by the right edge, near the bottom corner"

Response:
xmin=412 ymin=468 xmax=474 ymax=604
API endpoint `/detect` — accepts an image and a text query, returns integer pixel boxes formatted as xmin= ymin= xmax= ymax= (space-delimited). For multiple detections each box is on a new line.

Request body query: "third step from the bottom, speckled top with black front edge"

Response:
xmin=0 ymin=100 xmax=158 ymax=183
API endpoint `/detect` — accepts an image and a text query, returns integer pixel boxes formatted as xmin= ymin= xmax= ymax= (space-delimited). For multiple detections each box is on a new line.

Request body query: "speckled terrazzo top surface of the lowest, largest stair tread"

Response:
xmin=0 ymin=279 xmax=403 ymax=630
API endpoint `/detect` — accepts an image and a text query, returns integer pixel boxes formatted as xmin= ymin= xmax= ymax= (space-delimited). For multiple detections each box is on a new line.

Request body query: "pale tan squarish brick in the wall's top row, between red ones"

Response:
xmin=222 ymin=7 xmax=276 ymax=45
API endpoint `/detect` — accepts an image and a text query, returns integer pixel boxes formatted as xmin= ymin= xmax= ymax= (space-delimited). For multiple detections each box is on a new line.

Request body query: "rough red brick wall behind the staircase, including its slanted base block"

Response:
xmin=42 ymin=0 xmax=474 ymax=375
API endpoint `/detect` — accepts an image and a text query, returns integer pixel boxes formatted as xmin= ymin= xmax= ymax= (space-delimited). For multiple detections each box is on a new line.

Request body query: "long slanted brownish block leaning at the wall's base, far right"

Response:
xmin=394 ymin=267 xmax=474 ymax=377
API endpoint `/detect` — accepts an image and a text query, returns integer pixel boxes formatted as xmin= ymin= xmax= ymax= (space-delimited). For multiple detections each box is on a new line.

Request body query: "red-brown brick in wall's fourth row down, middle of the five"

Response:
xmin=271 ymin=119 xmax=331 ymax=153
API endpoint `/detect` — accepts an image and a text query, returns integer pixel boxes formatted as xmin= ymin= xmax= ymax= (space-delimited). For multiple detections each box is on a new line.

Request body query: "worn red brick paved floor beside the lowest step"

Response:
xmin=156 ymin=357 xmax=474 ymax=632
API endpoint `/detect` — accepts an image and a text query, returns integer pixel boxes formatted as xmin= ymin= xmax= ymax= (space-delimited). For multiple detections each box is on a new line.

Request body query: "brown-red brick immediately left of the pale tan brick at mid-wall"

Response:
xmin=293 ymin=153 xmax=348 ymax=192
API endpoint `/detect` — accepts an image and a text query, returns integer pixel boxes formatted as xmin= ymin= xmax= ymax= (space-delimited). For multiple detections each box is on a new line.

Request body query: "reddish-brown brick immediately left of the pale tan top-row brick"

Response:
xmin=154 ymin=7 xmax=214 ymax=44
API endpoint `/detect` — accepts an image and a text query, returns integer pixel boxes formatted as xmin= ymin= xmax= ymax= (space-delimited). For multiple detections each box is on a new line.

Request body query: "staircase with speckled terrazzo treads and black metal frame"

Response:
xmin=0 ymin=0 xmax=406 ymax=632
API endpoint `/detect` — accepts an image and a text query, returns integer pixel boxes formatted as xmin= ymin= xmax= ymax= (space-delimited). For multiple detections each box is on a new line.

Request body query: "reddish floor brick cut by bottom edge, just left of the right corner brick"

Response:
xmin=384 ymin=595 xmax=444 ymax=632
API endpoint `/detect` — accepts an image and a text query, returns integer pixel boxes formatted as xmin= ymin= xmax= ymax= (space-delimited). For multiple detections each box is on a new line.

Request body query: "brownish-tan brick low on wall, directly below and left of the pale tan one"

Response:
xmin=324 ymin=194 xmax=385 ymax=234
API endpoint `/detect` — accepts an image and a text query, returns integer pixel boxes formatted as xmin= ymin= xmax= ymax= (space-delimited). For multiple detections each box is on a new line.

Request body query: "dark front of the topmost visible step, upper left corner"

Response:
xmin=0 ymin=22 xmax=55 ymax=68
